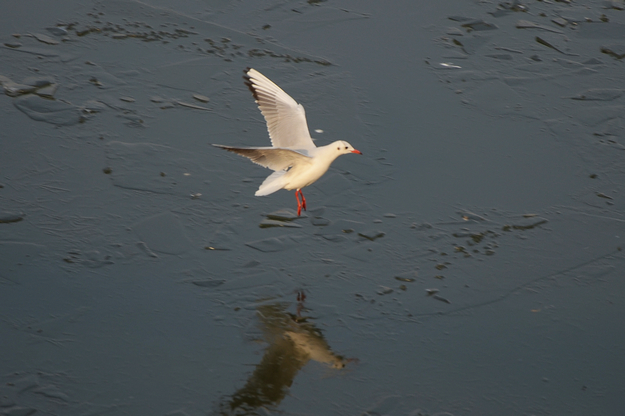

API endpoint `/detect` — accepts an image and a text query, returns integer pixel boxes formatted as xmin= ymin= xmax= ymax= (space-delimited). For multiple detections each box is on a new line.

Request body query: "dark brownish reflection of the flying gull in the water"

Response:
xmin=214 ymin=303 xmax=351 ymax=415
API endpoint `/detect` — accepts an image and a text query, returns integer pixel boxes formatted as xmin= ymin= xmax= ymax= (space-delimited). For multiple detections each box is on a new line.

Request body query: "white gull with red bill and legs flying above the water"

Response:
xmin=213 ymin=68 xmax=362 ymax=217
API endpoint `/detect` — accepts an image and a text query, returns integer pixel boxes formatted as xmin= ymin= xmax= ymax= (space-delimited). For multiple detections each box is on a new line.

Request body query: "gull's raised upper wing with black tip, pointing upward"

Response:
xmin=243 ymin=68 xmax=316 ymax=150
